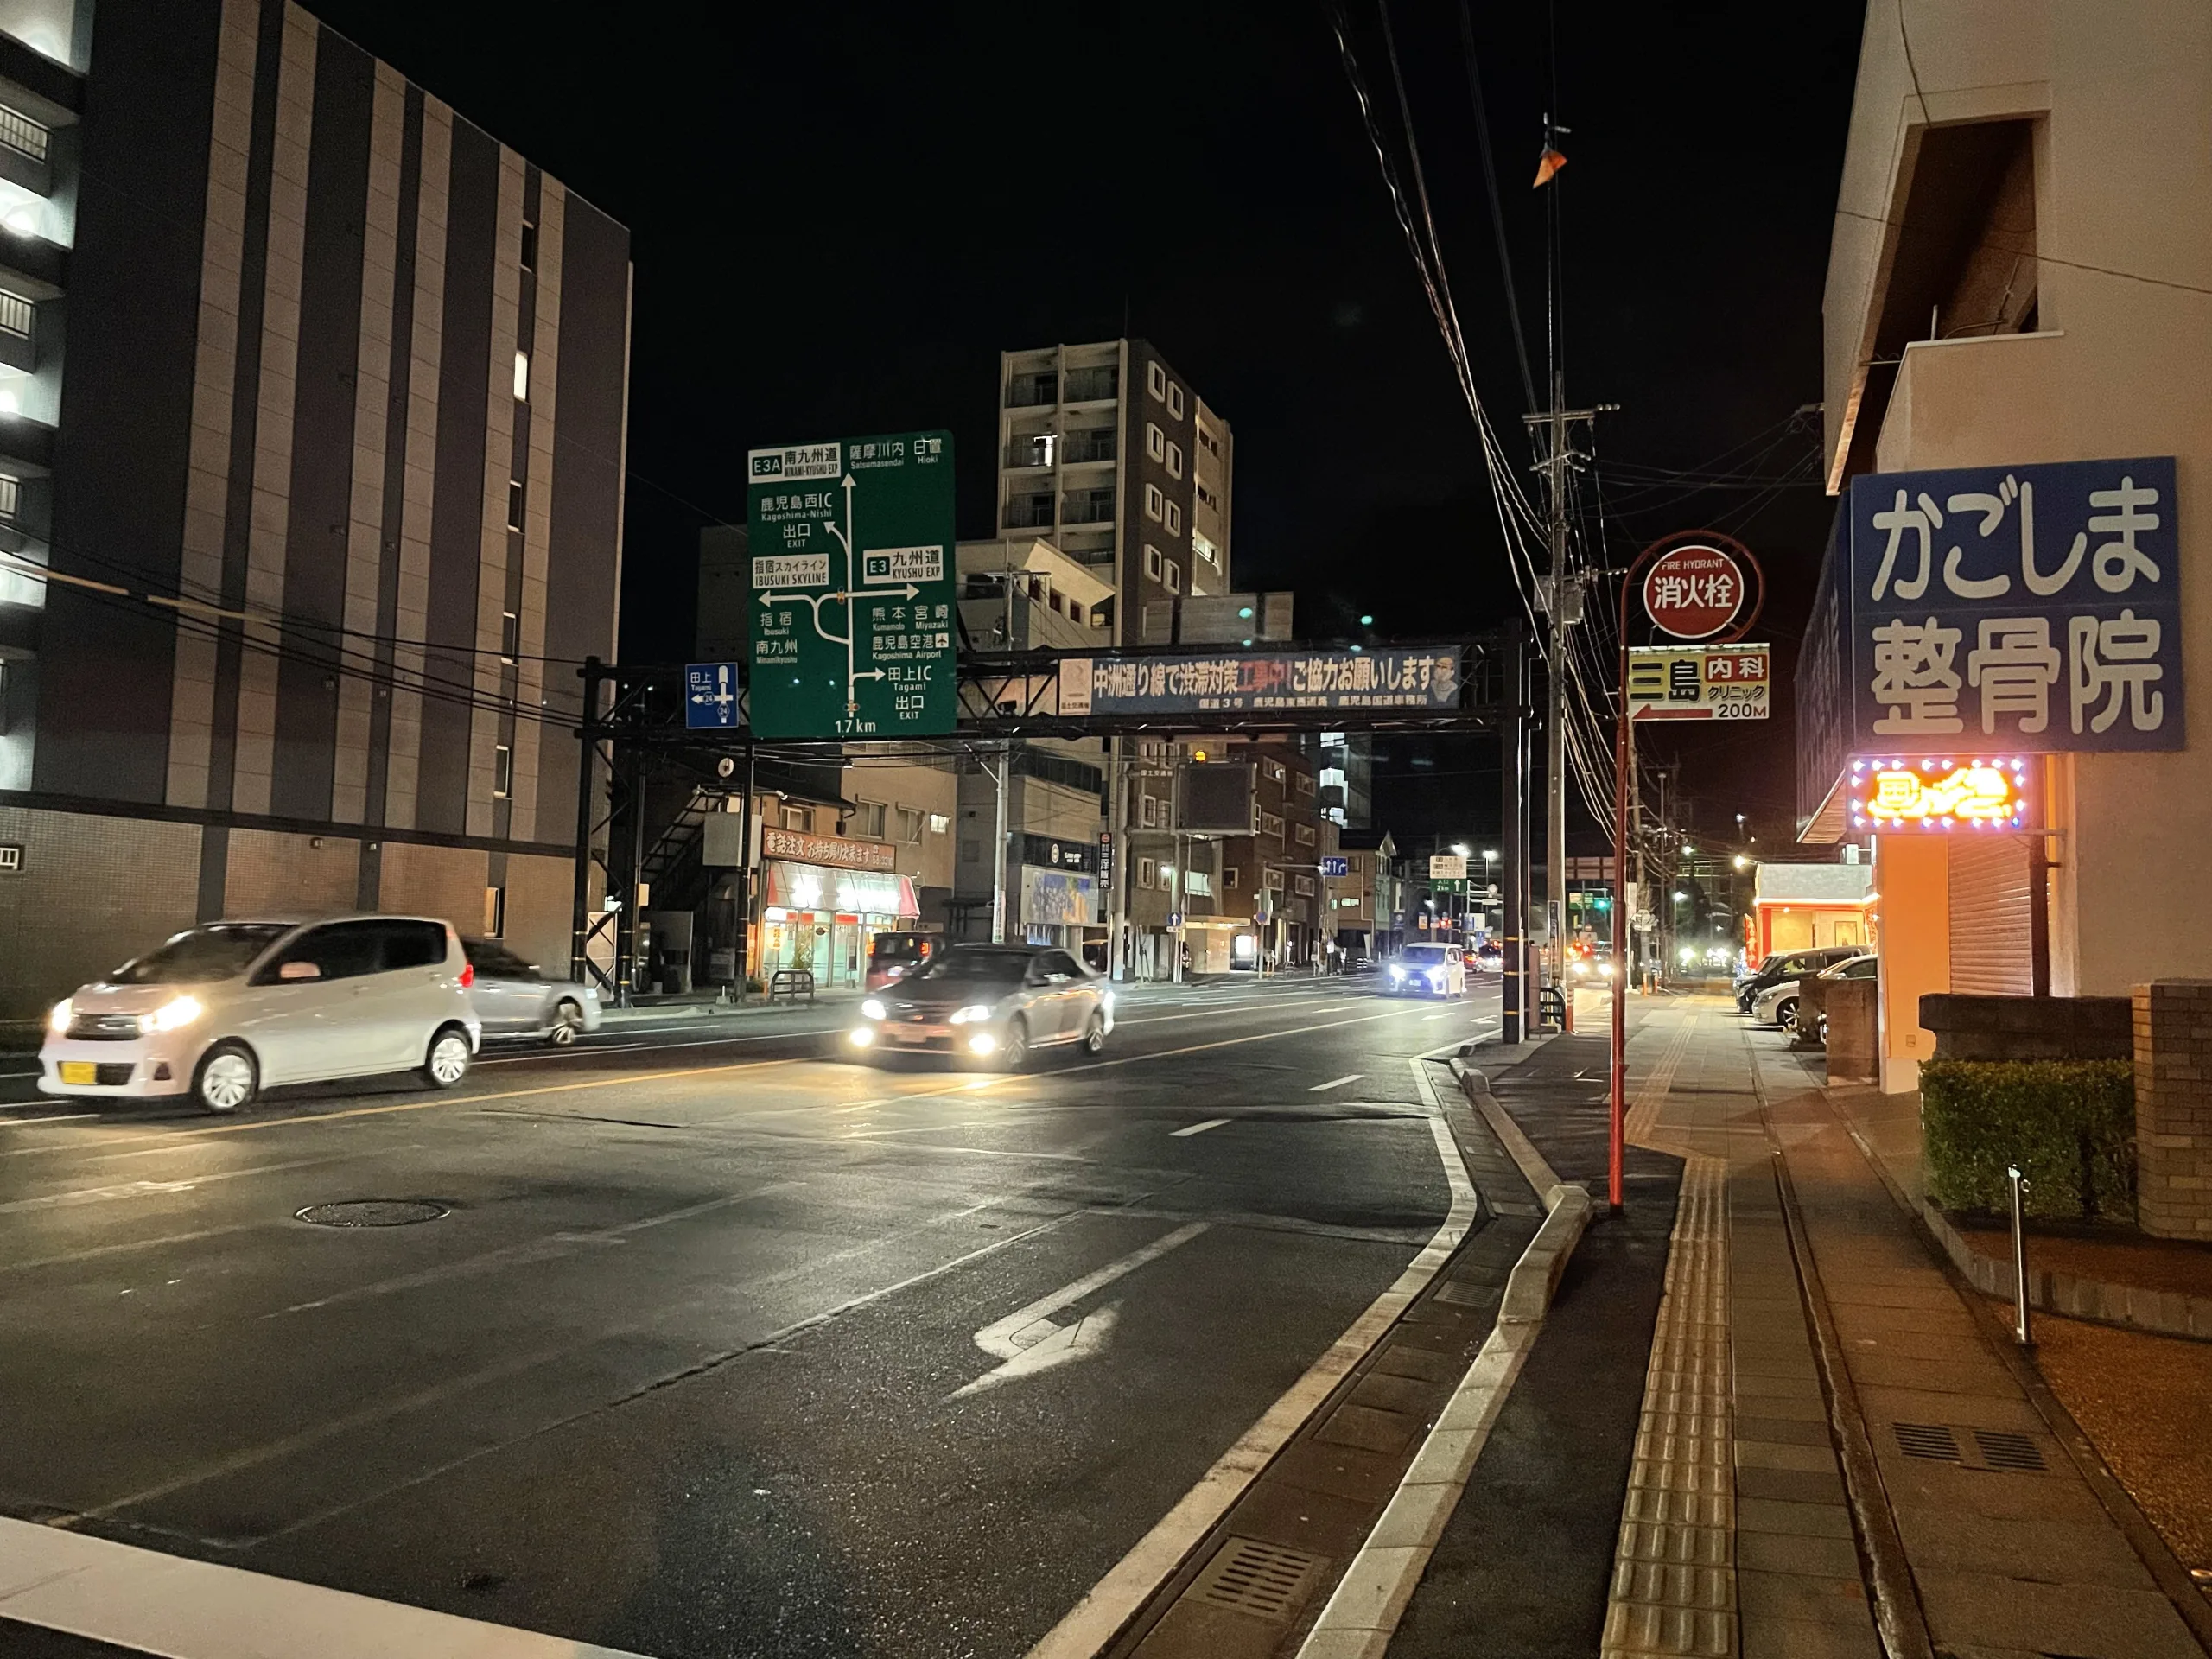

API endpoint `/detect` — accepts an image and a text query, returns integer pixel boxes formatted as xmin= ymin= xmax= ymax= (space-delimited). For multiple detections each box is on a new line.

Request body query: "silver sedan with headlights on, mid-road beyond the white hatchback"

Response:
xmin=847 ymin=944 xmax=1113 ymax=1071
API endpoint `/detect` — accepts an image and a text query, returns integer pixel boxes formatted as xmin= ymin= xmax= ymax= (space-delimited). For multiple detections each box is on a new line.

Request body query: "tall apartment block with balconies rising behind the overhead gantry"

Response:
xmin=998 ymin=340 xmax=1236 ymax=644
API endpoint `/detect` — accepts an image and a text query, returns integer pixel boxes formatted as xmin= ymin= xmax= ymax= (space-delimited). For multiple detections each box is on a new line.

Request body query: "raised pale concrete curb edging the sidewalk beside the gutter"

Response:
xmin=1299 ymin=1059 xmax=1592 ymax=1659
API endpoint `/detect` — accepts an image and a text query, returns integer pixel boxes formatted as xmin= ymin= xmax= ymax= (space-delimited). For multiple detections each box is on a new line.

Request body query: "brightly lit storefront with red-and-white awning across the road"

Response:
xmin=754 ymin=830 xmax=923 ymax=988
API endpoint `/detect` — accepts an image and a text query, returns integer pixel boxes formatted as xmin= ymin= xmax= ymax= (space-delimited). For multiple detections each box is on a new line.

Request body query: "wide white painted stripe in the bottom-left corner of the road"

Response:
xmin=0 ymin=1520 xmax=635 ymax=1659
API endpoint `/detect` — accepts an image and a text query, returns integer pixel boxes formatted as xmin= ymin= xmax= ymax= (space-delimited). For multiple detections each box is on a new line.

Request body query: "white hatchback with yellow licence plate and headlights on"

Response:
xmin=38 ymin=916 xmax=482 ymax=1113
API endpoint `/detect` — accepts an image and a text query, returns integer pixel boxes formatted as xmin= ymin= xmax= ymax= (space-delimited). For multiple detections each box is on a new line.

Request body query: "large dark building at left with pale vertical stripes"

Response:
xmin=0 ymin=0 xmax=631 ymax=1018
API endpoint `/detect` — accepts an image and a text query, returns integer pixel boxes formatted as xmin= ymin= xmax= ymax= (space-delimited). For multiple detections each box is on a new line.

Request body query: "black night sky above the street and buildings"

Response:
xmin=312 ymin=0 xmax=1863 ymax=852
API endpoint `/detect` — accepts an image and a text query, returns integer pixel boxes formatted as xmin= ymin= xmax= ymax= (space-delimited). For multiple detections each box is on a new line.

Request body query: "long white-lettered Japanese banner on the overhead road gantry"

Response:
xmin=1059 ymin=648 xmax=1460 ymax=716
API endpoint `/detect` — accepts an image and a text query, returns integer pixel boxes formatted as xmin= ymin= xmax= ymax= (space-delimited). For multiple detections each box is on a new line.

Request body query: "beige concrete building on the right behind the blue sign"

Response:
xmin=1801 ymin=0 xmax=2212 ymax=1090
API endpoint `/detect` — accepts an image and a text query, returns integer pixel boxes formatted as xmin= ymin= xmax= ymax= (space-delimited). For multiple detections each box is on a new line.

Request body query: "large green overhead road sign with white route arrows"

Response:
xmin=746 ymin=431 xmax=960 ymax=739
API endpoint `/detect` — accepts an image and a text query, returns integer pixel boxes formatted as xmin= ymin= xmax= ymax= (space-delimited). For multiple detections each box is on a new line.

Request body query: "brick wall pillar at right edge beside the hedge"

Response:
xmin=2134 ymin=980 xmax=2212 ymax=1241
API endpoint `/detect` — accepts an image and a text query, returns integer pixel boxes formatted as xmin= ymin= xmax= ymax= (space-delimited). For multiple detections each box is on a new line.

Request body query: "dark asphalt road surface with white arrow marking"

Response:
xmin=0 ymin=980 xmax=1497 ymax=1656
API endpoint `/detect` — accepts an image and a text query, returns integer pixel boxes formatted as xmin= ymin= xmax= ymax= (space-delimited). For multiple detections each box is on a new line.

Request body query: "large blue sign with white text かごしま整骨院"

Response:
xmin=1840 ymin=455 xmax=2183 ymax=754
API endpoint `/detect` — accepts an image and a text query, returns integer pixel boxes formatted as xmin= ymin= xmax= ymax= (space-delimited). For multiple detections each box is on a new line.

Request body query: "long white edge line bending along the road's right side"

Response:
xmin=1028 ymin=1044 xmax=1476 ymax=1659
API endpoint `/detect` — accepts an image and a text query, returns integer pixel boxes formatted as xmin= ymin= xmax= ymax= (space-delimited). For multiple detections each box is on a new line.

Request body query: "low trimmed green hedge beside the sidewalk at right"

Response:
xmin=1920 ymin=1059 xmax=2134 ymax=1221
